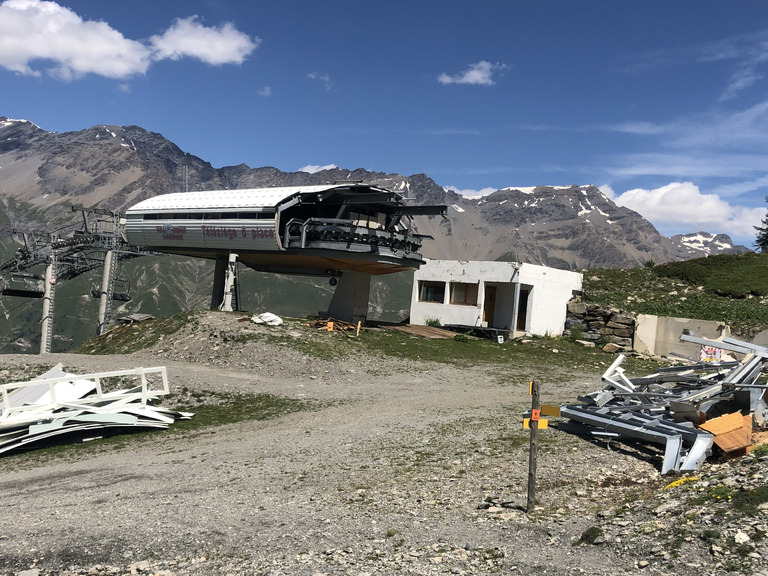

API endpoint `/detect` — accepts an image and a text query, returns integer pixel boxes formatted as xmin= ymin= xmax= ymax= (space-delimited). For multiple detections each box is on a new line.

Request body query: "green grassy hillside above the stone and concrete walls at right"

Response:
xmin=584 ymin=252 xmax=768 ymax=337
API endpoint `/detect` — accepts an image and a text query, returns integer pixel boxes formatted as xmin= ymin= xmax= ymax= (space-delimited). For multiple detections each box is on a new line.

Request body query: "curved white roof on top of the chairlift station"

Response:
xmin=127 ymin=184 xmax=347 ymax=214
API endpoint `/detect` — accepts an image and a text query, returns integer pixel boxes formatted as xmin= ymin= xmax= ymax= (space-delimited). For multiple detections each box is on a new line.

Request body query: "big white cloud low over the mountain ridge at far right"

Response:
xmin=600 ymin=182 xmax=766 ymax=238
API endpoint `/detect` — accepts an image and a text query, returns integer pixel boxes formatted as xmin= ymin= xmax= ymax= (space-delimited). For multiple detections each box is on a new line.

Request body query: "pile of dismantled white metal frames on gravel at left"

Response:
xmin=0 ymin=364 xmax=192 ymax=453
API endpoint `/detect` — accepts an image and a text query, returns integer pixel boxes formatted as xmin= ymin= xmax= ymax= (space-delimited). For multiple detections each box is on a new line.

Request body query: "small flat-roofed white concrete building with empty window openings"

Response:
xmin=411 ymin=260 xmax=582 ymax=337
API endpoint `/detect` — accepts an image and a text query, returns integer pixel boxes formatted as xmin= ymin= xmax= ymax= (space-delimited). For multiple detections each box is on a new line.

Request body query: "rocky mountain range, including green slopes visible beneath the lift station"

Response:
xmin=0 ymin=117 xmax=747 ymax=352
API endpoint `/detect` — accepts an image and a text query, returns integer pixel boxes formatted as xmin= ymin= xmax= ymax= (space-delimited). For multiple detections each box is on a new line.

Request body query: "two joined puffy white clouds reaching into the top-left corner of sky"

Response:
xmin=0 ymin=0 xmax=260 ymax=81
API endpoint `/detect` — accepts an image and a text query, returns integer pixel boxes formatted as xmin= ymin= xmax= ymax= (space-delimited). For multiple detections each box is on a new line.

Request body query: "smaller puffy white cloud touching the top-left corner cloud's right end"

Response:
xmin=150 ymin=16 xmax=261 ymax=66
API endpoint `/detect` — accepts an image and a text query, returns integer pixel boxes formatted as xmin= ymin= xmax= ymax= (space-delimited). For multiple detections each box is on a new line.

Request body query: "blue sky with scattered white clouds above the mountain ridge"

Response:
xmin=0 ymin=0 xmax=768 ymax=245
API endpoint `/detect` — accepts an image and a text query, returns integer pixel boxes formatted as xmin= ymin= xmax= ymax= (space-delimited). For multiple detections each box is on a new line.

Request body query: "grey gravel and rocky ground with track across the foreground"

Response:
xmin=0 ymin=314 xmax=768 ymax=576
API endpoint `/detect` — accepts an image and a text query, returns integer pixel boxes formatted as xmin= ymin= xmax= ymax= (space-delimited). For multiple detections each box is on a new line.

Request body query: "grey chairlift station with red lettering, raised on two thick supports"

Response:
xmin=125 ymin=181 xmax=446 ymax=322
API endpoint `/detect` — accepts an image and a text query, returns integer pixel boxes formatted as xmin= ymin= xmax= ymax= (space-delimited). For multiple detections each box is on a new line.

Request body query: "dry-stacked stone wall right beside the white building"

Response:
xmin=563 ymin=299 xmax=636 ymax=351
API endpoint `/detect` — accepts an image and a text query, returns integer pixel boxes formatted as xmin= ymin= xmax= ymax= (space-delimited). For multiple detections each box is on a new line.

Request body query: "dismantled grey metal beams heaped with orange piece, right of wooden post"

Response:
xmin=560 ymin=334 xmax=768 ymax=474
